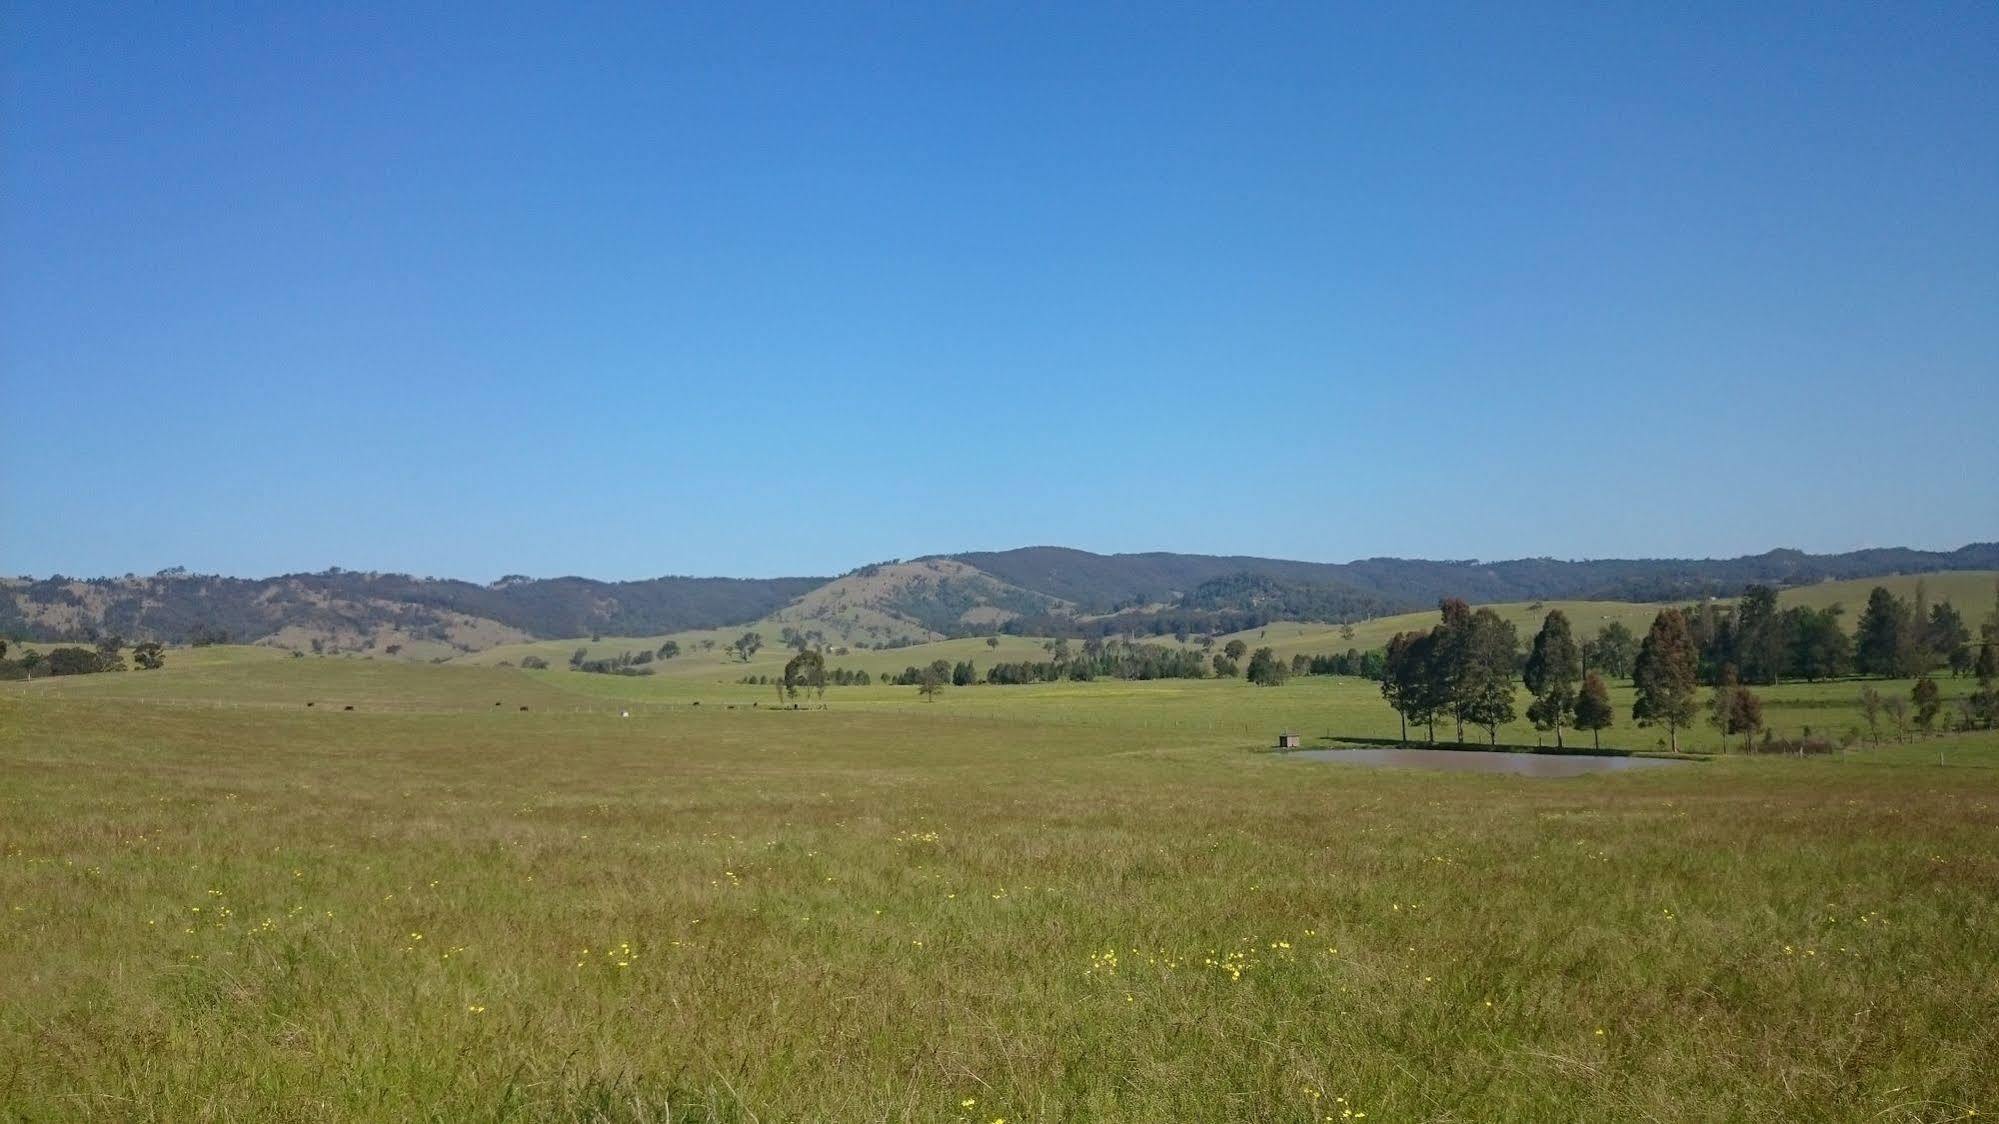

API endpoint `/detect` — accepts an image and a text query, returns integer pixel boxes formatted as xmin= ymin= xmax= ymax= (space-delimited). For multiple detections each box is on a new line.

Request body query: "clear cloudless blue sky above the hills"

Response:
xmin=0 ymin=0 xmax=1999 ymax=578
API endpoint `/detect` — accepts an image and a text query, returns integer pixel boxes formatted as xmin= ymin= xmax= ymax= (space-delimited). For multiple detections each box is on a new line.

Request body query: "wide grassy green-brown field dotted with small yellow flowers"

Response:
xmin=0 ymin=648 xmax=1999 ymax=1124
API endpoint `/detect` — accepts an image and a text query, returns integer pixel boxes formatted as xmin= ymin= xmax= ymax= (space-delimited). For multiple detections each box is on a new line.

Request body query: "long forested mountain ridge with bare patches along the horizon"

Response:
xmin=0 ymin=542 xmax=1999 ymax=656
